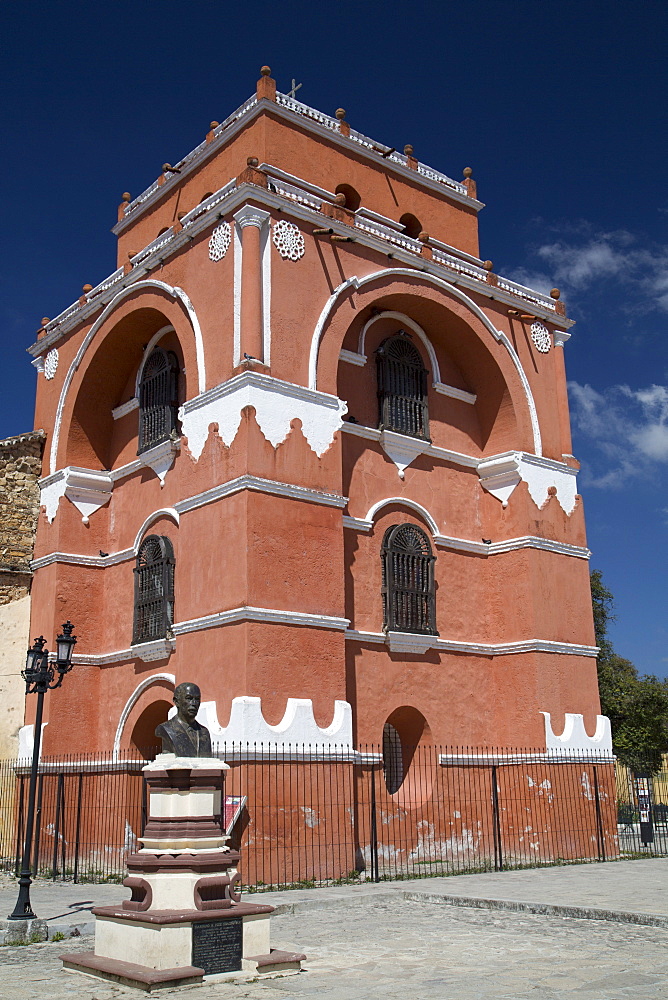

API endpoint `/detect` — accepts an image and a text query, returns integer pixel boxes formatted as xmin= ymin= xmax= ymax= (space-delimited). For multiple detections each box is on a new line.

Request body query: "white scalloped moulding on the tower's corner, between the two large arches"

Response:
xmin=179 ymin=372 xmax=348 ymax=460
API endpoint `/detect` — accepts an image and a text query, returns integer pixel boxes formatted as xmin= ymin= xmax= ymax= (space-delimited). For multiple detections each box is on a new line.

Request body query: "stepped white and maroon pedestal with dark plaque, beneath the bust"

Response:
xmin=61 ymin=754 xmax=304 ymax=991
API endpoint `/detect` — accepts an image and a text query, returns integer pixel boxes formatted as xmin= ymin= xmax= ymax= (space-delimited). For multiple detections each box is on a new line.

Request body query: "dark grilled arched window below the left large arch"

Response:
xmin=132 ymin=535 xmax=174 ymax=644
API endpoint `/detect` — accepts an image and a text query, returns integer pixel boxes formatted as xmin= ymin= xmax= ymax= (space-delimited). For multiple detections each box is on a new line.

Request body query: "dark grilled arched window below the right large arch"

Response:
xmin=381 ymin=524 xmax=438 ymax=635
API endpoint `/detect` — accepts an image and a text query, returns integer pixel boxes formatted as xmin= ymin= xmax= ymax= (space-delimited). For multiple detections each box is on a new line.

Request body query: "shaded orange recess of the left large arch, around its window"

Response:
xmin=61 ymin=306 xmax=188 ymax=469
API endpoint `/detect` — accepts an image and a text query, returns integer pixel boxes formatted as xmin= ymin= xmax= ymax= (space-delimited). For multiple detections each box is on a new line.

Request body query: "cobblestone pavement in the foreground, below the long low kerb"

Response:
xmin=0 ymin=895 xmax=668 ymax=1000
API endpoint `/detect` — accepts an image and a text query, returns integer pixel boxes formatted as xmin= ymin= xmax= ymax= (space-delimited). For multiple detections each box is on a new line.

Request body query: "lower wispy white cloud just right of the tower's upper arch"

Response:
xmin=568 ymin=382 xmax=668 ymax=488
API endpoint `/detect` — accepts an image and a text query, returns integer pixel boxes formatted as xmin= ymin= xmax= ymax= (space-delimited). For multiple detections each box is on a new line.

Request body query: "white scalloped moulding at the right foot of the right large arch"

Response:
xmin=478 ymin=451 xmax=577 ymax=514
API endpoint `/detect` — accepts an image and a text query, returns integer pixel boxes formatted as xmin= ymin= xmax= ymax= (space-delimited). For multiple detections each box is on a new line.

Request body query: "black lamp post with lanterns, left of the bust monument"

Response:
xmin=9 ymin=622 xmax=77 ymax=920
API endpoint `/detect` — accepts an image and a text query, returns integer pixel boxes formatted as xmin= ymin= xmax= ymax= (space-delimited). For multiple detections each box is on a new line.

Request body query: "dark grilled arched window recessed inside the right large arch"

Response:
xmin=376 ymin=330 xmax=429 ymax=441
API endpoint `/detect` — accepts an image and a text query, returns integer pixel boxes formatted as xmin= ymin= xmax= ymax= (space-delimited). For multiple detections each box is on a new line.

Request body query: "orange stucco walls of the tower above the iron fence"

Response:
xmin=27 ymin=80 xmax=599 ymax=753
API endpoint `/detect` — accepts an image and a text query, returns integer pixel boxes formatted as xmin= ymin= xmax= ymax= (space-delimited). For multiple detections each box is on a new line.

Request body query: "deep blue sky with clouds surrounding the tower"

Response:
xmin=0 ymin=0 xmax=668 ymax=676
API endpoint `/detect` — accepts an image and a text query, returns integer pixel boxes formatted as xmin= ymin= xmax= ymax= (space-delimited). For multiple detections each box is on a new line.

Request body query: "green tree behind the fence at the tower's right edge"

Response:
xmin=591 ymin=570 xmax=668 ymax=774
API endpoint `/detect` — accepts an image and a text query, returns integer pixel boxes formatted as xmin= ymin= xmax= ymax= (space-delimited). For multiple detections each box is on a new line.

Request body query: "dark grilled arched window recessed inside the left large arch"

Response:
xmin=137 ymin=347 xmax=179 ymax=455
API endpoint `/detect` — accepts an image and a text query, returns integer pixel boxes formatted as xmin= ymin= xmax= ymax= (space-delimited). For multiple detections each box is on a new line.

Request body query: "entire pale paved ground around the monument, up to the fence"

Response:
xmin=0 ymin=859 xmax=668 ymax=1000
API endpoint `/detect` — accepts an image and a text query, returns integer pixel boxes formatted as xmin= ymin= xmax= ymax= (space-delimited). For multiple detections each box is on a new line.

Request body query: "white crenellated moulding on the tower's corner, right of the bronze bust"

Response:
xmin=197 ymin=696 xmax=353 ymax=753
